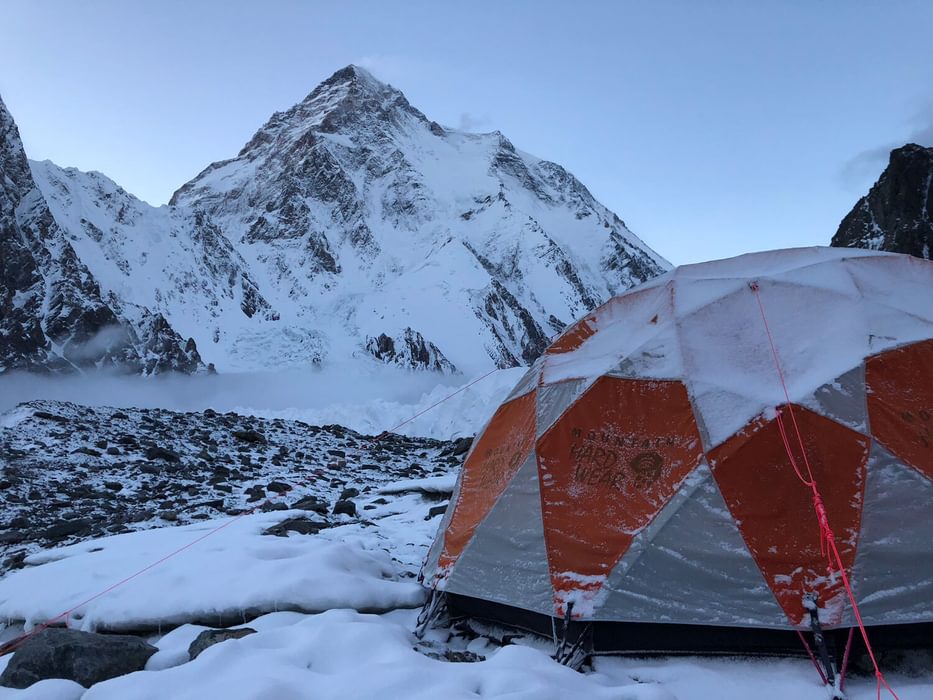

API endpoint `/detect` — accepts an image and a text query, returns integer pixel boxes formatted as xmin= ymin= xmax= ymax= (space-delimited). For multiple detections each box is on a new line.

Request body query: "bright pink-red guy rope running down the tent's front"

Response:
xmin=749 ymin=282 xmax=899 ymax=700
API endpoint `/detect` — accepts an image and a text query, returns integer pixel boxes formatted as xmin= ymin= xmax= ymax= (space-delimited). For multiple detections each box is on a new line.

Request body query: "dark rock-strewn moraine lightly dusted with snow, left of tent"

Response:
xmin=0 ymin=401 xmax=470 ymax=575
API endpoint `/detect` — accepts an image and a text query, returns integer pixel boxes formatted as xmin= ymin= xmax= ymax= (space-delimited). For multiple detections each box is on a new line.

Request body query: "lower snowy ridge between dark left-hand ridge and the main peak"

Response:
xmin=30 ymin=161 xmax=277 ymax=372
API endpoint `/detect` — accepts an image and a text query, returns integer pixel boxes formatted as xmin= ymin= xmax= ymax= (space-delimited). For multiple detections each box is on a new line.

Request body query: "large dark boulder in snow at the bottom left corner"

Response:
xmin=0 ymin=628 xmax=158 ymax=688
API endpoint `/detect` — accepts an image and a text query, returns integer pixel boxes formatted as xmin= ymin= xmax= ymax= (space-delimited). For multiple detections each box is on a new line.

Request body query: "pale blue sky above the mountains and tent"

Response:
xmin=0 ymin=0 xmax=933 ymax=264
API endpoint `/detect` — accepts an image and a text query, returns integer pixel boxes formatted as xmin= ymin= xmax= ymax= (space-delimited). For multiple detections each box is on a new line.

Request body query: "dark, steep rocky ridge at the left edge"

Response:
xmin=0 ymin=101 xmax=205 ymax=374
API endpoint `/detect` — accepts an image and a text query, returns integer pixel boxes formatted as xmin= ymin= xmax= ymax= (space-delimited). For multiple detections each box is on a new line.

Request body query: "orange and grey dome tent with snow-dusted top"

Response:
xmin=422 ymin=248 xmax=933 ymax=656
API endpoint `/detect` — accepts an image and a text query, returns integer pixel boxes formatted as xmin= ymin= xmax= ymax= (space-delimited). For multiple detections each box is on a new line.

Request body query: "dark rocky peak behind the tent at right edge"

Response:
xmin=832 ymin=144 xmax=933 ymax=260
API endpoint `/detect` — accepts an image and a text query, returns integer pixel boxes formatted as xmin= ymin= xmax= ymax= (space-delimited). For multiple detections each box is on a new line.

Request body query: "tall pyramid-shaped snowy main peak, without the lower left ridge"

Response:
xmin=172 ymin=66 xmax=667 ymax=370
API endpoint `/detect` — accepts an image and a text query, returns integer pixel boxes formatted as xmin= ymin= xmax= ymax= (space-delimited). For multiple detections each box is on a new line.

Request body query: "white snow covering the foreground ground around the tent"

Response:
xmin=0 ymin=370 xmax=933 ymax=700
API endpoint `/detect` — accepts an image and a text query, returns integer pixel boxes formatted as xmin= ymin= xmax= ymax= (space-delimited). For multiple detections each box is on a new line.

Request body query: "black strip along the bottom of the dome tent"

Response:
xmin=446 ymin=593 xmax=933 ymax=656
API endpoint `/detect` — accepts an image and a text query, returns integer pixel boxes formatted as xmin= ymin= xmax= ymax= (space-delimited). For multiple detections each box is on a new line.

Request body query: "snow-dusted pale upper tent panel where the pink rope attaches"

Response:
xmin=678 ymin=279 xmax=870 ymax=448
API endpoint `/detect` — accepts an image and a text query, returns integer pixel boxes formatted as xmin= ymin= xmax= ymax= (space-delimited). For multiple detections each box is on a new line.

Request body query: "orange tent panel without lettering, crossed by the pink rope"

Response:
xmin=709 ymin=406 xmax=871 ymax=627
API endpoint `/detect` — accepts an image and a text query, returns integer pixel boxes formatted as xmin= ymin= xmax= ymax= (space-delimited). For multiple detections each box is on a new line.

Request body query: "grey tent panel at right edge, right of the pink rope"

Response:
xmin=850 ymin=444 xmax=933 ymax=625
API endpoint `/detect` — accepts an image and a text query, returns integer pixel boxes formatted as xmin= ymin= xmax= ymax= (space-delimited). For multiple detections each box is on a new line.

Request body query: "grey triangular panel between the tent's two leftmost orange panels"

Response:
xmin=444 ymin=454 xmax=554 ymax=615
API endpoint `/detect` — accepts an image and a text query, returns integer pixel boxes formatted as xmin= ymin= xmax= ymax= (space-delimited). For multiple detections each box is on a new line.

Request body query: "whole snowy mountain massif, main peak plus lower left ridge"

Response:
xmin=1 ymin=66 xmax=669 ymax=372
